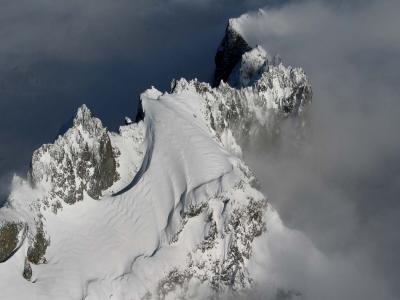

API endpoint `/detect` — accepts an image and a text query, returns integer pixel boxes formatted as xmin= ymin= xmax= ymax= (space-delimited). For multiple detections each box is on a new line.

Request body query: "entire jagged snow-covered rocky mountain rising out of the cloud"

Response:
xmin=0 ymin=10 xmax=312 ymax=299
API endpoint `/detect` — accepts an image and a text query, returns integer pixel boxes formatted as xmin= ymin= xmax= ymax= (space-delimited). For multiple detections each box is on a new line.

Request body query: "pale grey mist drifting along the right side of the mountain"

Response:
xmin=241 ymin=1 xmax=400 ymax=299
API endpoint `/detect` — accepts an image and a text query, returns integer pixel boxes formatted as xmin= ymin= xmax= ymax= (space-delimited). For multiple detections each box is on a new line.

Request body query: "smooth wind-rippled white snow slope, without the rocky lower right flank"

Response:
xmin=0 ymin=89 xmax=264 ymax=299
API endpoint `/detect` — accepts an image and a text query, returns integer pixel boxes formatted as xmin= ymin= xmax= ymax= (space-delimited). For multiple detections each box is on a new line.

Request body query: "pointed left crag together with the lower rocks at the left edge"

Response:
xmin=0 ymin=105 xmax=119 ymax=280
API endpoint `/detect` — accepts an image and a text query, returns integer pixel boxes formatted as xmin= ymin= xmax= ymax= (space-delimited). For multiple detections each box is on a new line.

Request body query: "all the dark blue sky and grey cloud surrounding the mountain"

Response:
xmin=0 ymin=0 xmax=400 ymax=298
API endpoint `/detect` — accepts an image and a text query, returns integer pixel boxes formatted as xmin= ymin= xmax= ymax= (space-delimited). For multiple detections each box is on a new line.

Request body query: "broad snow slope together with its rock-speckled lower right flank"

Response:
xmin=0 ymin=85 xmax=267 ymax=299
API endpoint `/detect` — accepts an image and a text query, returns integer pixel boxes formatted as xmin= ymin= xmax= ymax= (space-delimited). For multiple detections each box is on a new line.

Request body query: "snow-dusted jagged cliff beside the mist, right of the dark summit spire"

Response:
xmin=172 ymin=51 xmax=312 ymax=149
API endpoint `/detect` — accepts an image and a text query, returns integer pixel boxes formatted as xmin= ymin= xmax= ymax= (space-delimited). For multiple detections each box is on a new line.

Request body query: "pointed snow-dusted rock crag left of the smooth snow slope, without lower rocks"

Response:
xmin=29 ymin=105 xmax=119 ymax=210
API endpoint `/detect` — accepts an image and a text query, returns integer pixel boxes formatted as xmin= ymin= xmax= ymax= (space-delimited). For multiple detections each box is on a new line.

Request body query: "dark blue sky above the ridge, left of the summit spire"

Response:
xmin=0 ymin=0 xmax=284 ymax=195
